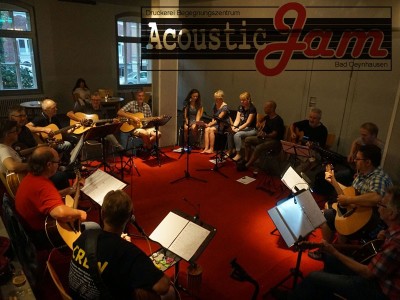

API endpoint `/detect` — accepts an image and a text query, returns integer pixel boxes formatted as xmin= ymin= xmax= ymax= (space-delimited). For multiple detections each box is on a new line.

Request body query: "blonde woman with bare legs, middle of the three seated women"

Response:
xmin=200 ymin=90 xmax=230 ymax=154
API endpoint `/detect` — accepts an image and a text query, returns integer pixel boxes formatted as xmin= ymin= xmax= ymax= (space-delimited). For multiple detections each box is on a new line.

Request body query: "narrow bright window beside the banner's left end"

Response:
xmin=116 ymin=15 xmax=151 ymax=87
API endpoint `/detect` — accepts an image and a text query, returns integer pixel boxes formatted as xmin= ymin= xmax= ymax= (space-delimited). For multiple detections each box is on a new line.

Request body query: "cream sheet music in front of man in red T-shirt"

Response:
xmin=81 ymin=169 xmax=126 ymax=206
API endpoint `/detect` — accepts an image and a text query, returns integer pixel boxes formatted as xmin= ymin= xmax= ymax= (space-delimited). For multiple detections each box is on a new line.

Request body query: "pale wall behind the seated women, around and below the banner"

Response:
xmin=174 ymin=0 xmax=400 ymax=182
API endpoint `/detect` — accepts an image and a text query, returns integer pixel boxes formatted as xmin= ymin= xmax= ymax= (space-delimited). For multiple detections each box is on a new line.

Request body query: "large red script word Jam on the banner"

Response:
xmin=254 ymin=2 xmax=389 ymax=76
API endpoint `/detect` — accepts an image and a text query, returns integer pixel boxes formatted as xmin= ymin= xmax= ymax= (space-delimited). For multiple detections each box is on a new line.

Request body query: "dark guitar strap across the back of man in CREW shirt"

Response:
xmin=85 ymin=229 xmax=114 ymax=300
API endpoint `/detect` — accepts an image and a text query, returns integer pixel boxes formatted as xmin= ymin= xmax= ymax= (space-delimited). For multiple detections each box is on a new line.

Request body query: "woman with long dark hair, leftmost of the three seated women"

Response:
xmin=183 ymin=89 xmax=203 ymax=145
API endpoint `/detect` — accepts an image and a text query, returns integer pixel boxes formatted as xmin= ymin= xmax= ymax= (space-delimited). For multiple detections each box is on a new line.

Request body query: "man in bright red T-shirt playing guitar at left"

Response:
xmin=15 ymin=147 xmax=86 ymax=249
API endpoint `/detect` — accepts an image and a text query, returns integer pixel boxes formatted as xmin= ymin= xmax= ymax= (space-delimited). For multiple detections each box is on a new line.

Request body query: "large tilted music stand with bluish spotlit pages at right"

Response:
xmin=268 ymin=190 xmax=326 ymax=292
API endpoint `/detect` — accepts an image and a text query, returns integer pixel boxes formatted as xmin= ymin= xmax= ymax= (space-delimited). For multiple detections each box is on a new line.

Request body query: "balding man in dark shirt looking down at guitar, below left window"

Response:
xmin=26 ymin=99 xmax=77 ymax=162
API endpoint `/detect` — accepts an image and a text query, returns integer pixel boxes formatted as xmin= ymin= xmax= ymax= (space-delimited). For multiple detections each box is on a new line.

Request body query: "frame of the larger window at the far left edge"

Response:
xmin=0 ymin=0 xmax=43 ymax=96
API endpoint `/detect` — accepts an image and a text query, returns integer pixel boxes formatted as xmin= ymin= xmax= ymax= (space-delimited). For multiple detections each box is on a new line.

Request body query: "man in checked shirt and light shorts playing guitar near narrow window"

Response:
xmin=117 ymin=90 xmax=161 ymax=149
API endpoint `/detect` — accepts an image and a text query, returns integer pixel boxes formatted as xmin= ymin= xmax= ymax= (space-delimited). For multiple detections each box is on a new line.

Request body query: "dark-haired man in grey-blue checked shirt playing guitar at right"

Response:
xmin=309 ymin=145 xmax=392 ymax=259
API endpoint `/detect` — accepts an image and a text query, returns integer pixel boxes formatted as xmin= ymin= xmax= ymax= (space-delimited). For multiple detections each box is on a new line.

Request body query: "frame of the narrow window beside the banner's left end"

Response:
xmin=115 ymin=12 xmax=152 ymax=90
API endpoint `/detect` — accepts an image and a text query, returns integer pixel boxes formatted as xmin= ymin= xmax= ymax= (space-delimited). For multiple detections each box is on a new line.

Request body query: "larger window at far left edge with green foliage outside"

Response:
xmin=0 ymin=0 xmax=38 ymax=95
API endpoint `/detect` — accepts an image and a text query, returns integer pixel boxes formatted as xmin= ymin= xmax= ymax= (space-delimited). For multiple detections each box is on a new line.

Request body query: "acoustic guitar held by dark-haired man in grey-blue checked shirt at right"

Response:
xmin=325 ymin=164 xmax=373 ymax=235
